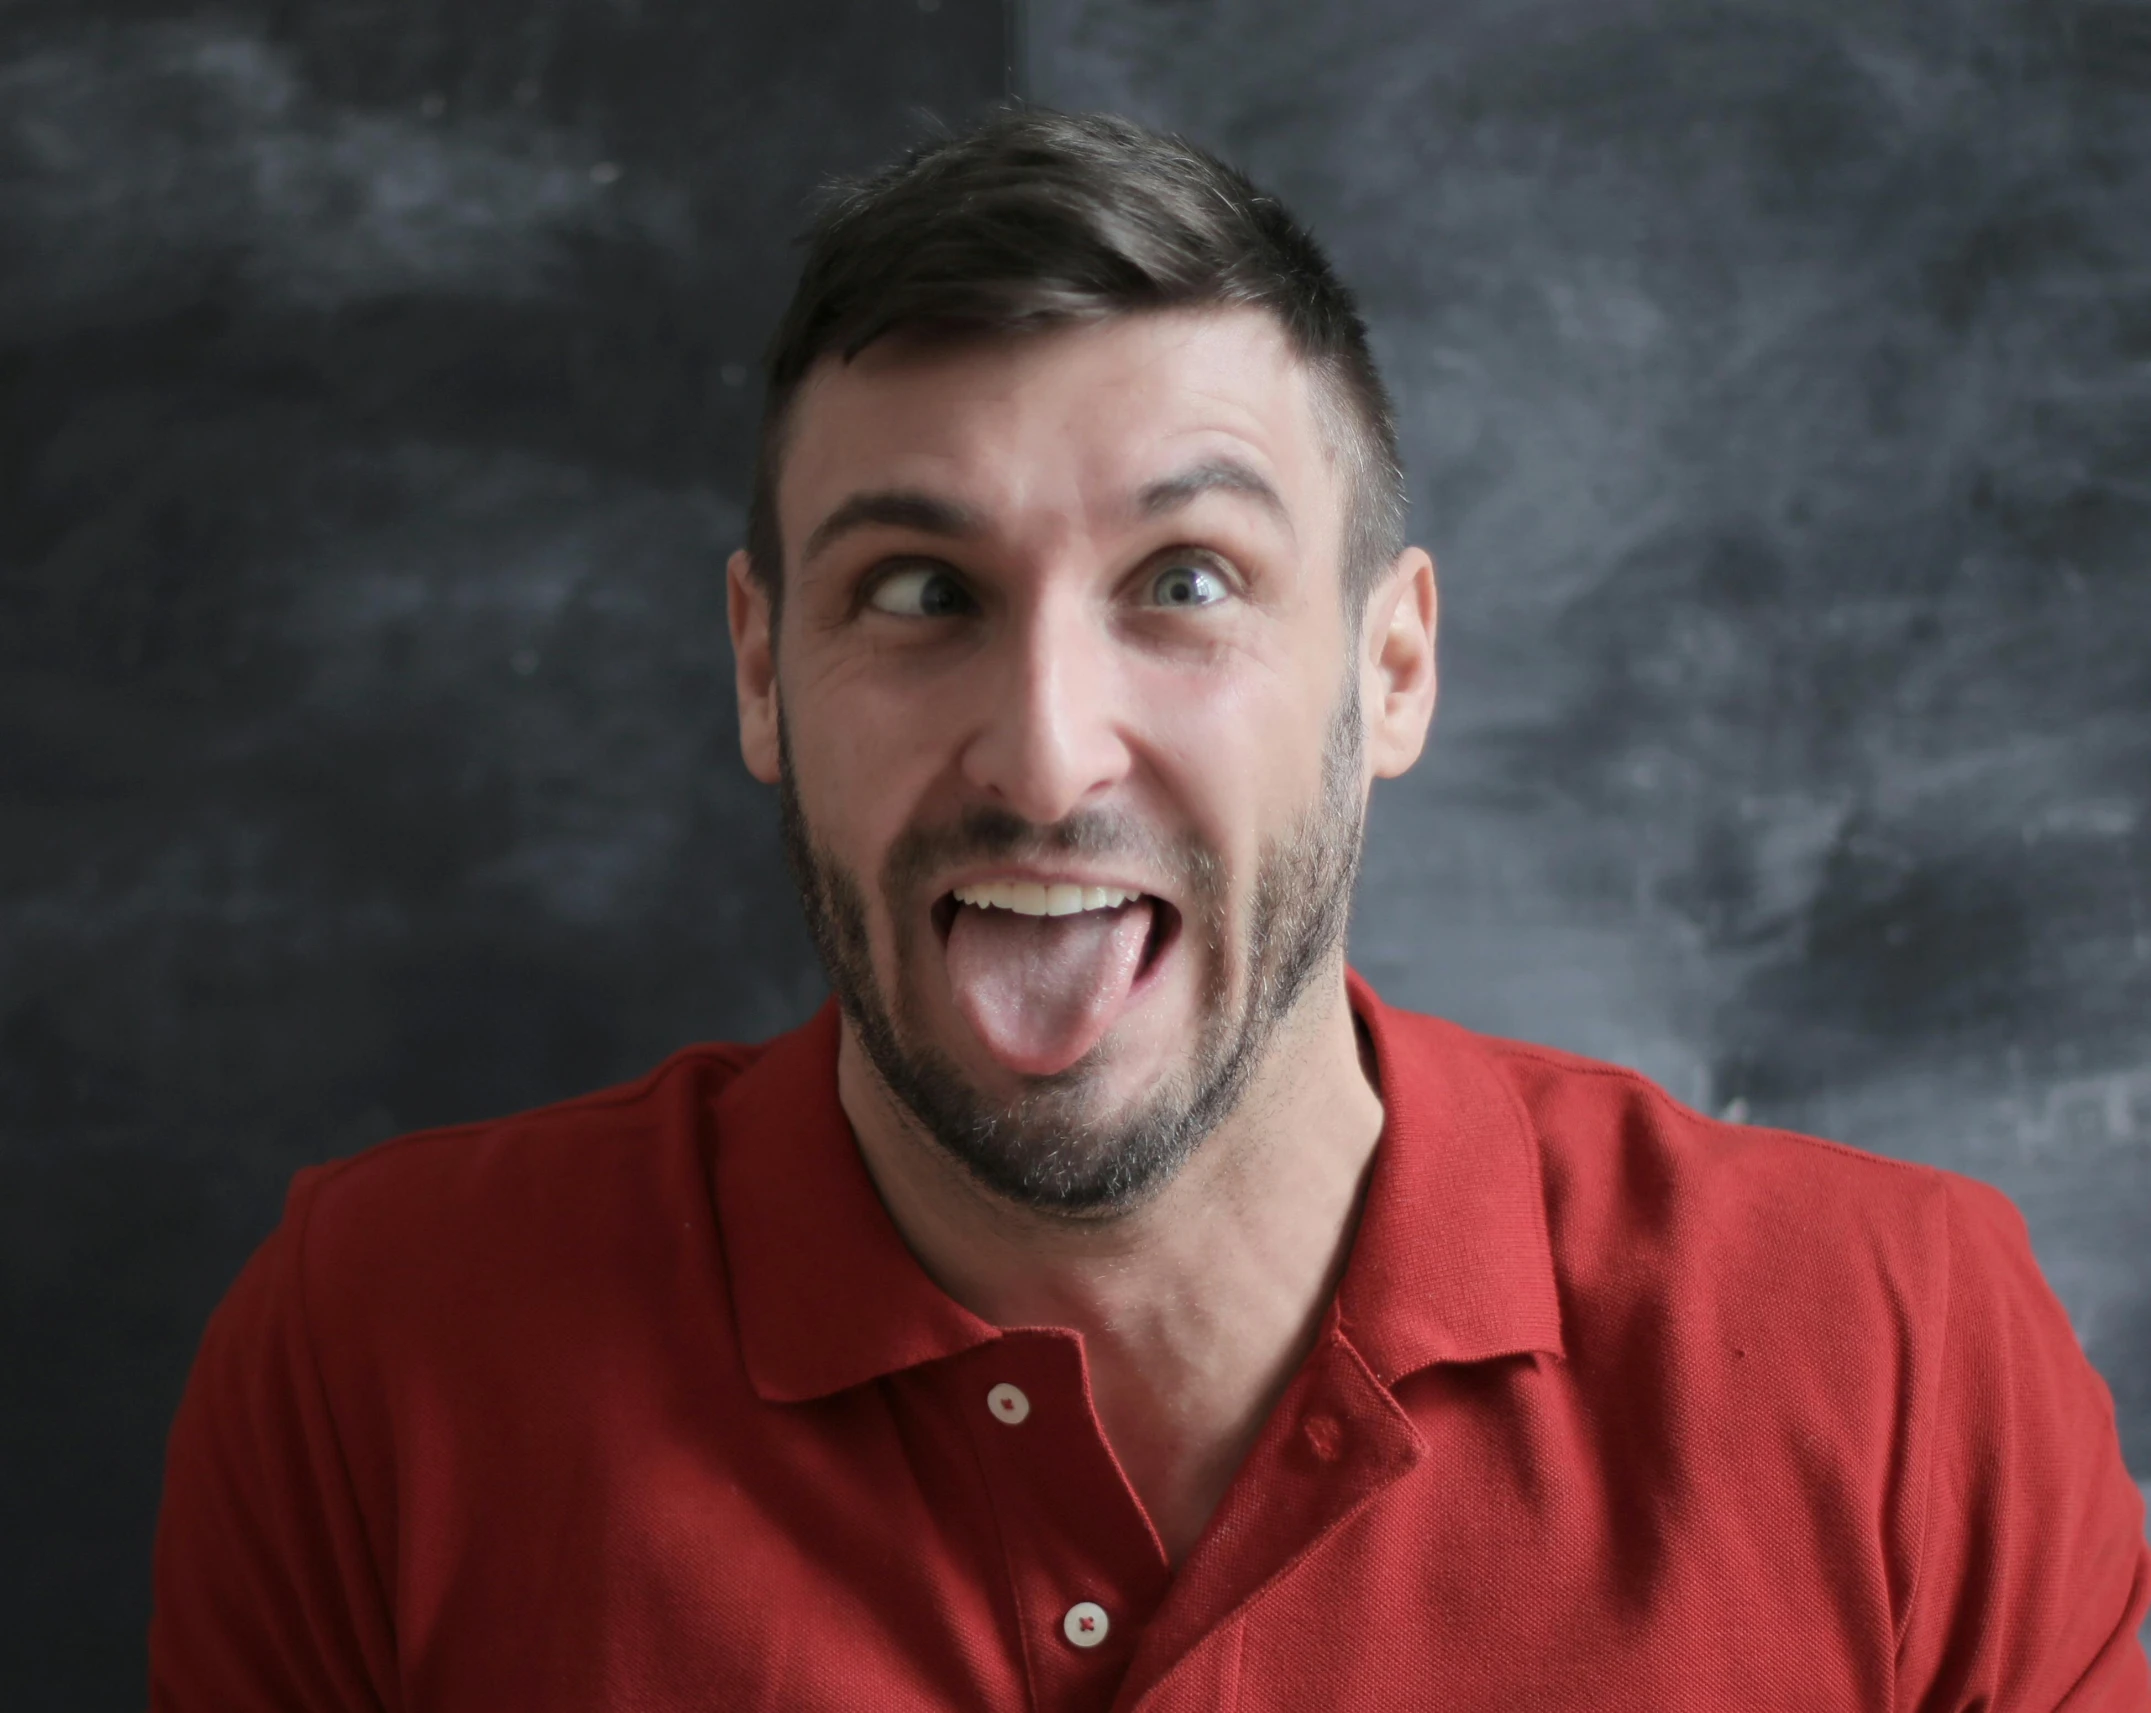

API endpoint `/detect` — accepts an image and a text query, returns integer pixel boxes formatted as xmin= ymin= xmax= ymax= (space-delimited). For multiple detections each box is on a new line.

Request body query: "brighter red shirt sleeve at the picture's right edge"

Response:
xmin=1897 ymin=1179 xmax=2151 ymax=1713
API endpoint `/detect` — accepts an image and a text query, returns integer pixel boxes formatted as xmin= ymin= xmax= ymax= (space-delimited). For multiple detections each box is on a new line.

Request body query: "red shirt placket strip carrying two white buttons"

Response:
xmin=949 ymin=1332 xmax=1170 ymax=1713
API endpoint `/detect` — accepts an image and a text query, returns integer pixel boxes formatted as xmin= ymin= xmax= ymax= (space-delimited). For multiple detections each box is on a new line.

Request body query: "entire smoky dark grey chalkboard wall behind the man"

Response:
xmin=0 ymin=0 xmax=2151 ymax=1709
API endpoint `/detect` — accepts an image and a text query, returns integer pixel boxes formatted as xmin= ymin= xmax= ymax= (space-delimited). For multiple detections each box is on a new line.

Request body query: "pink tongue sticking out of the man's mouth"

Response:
xmin=949 ymin=900 xmax=1155 ymax=1076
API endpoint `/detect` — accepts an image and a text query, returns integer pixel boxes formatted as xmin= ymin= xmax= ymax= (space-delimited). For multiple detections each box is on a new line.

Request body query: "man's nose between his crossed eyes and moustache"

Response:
xmin=964 ymin=600 xmax=1131 ymax=826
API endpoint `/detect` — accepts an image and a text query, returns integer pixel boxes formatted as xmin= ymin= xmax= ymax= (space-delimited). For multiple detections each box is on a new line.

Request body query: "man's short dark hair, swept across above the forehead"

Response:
xmin=746 ymin=105 xmax=1405 ymax=613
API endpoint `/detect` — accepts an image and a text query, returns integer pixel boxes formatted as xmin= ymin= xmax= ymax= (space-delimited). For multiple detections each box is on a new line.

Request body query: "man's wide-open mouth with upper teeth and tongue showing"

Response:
xmin=931 ymin=867 xmax=1183 ymax=1078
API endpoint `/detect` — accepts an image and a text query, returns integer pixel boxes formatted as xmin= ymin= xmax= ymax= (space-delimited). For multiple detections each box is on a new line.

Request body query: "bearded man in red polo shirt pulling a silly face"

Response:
xmin=153 ymin=112 xmax=2151 ymax=1711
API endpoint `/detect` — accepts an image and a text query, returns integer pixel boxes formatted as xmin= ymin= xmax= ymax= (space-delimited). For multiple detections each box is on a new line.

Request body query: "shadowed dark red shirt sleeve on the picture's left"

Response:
xmin=148 ymin=1175 xmax=398 ymax=1713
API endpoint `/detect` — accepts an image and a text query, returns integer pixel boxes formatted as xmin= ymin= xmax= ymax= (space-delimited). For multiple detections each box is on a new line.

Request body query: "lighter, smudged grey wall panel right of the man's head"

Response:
xmin=1026 ymin=0 xmax=2151 ymax=1515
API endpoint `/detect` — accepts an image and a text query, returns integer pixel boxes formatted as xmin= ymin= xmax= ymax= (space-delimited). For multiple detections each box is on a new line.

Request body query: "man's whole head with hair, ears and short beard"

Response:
xmin=731 ymin=112 xmax=1433 ymax=1212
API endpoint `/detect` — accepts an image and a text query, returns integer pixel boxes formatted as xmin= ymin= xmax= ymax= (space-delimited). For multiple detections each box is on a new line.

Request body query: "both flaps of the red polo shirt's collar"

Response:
xmin=712 ymin=973 xmax=1562 ymax=1403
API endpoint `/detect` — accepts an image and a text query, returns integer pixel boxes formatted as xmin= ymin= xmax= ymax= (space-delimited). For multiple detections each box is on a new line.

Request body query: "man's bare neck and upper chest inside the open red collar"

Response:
xmin=837 ymin=971 xmax=1383 ymax=1562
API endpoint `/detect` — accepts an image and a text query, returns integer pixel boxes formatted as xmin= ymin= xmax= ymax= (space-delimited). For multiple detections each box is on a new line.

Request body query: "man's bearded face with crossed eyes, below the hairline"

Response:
xmin=733 ymin=312 xmax=1402 ymax=1212
